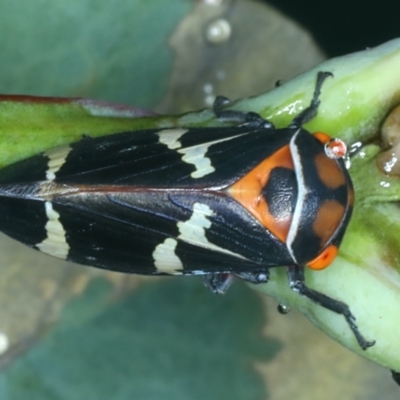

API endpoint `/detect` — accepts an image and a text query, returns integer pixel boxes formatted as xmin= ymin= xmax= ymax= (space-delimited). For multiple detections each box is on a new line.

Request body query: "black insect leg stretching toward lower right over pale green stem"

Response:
xmin=287 ymin=265 xmax=375 ymax=350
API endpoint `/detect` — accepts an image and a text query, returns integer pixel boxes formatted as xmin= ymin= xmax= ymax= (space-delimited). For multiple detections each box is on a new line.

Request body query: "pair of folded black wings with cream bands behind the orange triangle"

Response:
xmin=0 ymin=127 xmax=293 ymax=274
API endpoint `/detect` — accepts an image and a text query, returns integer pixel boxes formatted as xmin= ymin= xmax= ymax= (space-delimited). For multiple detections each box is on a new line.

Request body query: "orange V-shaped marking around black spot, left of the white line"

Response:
xmin=227 ymin=145 xmax=294 ymax=243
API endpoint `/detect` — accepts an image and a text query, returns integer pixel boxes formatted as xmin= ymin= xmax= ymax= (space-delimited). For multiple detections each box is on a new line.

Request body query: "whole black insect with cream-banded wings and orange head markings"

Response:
xmin=0 ymin=72 xmax=374 ymax=349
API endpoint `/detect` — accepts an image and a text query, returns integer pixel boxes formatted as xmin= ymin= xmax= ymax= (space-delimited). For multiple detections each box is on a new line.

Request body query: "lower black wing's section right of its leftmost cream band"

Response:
xmin=45 ymin=191 xmax=291 ymax=274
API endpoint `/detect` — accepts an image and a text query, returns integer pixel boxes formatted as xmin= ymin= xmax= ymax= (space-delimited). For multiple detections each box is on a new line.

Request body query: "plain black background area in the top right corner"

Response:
xmin=267 ymin=0 xmax=400 ymax=57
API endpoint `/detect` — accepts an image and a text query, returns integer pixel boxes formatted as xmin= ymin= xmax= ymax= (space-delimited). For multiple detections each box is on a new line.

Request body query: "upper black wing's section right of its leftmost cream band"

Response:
xmin=46 ymin=127 xmax=292 ymax=187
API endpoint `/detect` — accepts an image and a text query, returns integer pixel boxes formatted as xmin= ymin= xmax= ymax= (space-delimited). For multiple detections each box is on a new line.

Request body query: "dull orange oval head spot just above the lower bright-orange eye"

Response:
xmin=312 ymin=200 xmax=346 ymax=248
